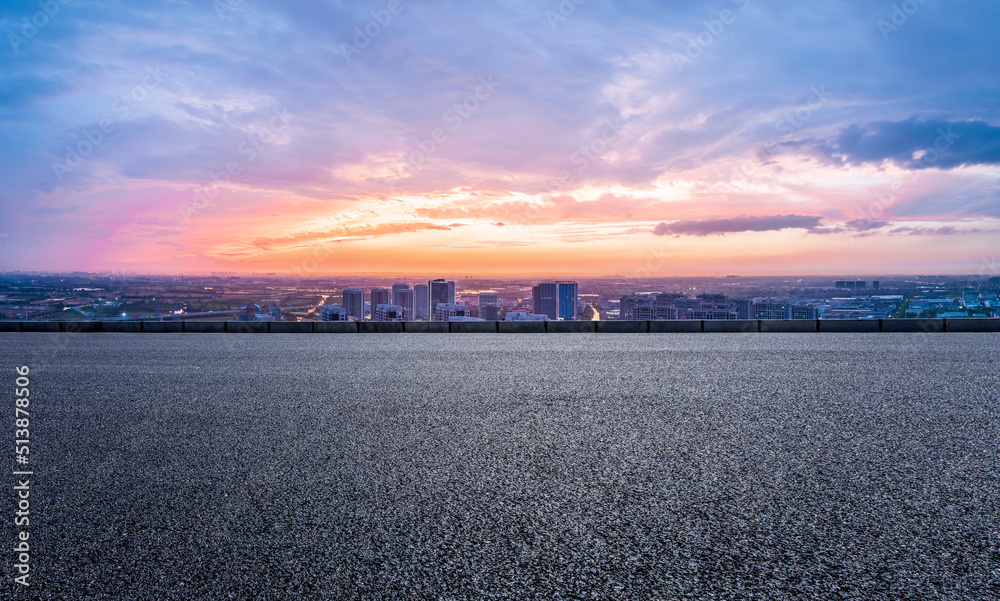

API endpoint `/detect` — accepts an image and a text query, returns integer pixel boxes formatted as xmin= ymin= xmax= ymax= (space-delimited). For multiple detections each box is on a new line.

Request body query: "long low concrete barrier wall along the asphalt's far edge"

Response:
xmin=0 ymin=319 xmax=1000 ymax=334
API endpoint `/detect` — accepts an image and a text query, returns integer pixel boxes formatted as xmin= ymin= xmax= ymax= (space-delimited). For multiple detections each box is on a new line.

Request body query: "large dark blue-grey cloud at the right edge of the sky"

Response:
xmin=814 ymin=116 xmax=1000 ymax=170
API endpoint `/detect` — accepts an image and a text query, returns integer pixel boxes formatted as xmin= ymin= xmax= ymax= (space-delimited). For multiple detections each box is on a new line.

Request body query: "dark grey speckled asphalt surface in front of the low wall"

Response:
xmin=0 ymin=334 xmax=1000 ymax=600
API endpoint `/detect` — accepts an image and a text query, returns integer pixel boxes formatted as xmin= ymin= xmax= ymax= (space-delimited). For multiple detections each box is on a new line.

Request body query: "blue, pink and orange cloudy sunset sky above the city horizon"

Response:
xmin=0 ymin=0 xmax=1000 ymax=277
